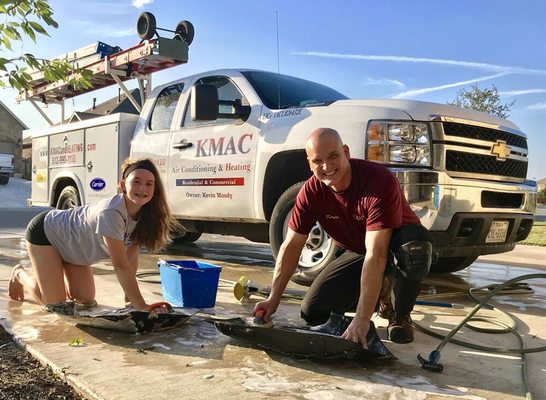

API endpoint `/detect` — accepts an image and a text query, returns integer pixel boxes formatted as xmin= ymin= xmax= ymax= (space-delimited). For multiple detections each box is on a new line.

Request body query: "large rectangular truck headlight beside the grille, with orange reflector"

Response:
xmin=366 ymin=121 xmax=430 ymax=166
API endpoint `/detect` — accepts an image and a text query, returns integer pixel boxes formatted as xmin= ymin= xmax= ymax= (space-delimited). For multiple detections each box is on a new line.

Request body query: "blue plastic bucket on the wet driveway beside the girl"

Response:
xmin=157 ymin=260 xmax=222 ymax=308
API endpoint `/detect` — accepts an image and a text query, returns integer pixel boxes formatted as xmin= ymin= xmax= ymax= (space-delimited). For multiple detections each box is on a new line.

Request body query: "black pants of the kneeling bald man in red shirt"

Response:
xmin=301 ymin=225 xmax=432 ymax=325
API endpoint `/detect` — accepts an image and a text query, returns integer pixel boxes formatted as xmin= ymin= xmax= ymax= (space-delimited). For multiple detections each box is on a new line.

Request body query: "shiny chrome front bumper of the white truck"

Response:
xmin=393 ymin=170 xmax=537 ymax=257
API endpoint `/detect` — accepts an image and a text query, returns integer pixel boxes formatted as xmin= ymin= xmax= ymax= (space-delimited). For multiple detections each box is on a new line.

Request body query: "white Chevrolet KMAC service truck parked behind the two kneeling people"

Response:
xmin=27 ymin=70 xmax=536 ymax=284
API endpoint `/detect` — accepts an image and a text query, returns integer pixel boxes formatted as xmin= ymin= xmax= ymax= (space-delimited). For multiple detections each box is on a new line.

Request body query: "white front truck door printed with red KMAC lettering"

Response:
xmin=168 ymin=76 xmax=258 ymax=220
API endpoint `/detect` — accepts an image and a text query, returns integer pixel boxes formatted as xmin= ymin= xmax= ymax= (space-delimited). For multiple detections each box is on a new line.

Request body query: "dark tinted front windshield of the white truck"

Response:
xmin=241 ymin=71 xmax=347 ymax=110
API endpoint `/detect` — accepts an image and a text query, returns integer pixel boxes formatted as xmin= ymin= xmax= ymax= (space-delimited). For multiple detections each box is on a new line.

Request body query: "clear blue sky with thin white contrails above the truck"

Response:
xmin=0 ymin=0 xmax=546 ymax=180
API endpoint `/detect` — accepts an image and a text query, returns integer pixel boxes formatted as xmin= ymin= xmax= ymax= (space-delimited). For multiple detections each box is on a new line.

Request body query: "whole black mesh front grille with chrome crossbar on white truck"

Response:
xmin=442 ymin=122 xmax=528 ymax=180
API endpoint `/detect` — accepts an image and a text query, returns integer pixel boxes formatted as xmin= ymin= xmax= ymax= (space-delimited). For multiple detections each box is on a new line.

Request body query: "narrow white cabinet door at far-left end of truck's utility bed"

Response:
xmin=31 ymin=136 xmax=49 ymax=205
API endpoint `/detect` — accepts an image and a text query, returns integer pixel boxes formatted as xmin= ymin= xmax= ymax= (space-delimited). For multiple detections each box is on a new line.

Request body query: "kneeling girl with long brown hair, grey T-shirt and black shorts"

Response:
xmin=9 ymin=159 xmax=173 ymax=310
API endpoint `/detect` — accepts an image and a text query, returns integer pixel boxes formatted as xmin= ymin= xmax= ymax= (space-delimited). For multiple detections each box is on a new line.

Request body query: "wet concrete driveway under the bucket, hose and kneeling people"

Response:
xmin=0 ymin=235 xmax=546 ymax=400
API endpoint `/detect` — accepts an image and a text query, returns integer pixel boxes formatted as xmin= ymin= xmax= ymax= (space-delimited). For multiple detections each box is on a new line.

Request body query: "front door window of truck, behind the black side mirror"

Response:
xmin=182 ymin=76 xmax=248 ymax=128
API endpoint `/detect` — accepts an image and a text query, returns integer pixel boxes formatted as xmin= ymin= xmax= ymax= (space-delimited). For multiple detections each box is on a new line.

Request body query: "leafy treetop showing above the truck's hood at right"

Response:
xmin=448 ymin=83 xmax=516 ymax=118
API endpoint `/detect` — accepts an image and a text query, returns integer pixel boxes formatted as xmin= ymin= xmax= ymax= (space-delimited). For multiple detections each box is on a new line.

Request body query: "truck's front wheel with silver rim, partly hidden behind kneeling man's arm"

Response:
xmin=269 ymin=182 xmax=340 ymax=286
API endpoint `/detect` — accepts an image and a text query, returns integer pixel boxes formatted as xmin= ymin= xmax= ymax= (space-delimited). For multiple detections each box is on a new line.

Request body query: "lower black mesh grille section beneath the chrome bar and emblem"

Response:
xmin=446 ymin=150 xmax=527 ymax=179
